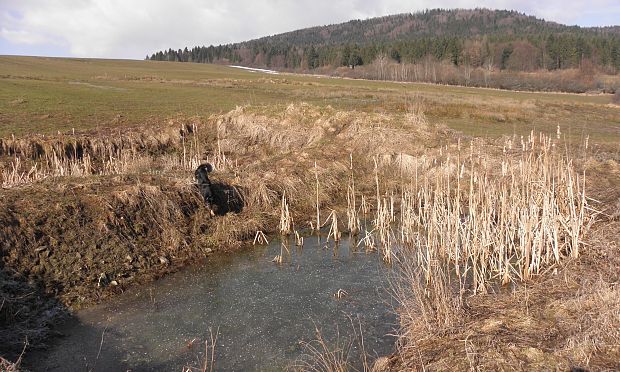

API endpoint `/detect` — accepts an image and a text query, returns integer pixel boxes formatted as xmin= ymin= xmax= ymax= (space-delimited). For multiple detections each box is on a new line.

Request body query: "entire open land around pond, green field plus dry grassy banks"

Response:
xmin=0 ymin=57 xmax=620 ymax=370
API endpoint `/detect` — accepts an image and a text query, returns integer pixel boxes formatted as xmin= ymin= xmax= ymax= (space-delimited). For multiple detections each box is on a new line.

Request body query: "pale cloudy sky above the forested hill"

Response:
xmin=0 ymin=0 xmax=620 ymax=59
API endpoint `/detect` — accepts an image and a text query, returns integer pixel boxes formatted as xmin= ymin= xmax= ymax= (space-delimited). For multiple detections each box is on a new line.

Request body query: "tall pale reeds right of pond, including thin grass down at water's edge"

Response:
xmin=390 ymin=132 xmax=596 ymax=354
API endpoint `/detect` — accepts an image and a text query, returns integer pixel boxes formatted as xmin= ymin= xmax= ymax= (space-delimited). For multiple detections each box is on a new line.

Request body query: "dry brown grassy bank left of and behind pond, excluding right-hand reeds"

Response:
xmin=0 ymin=104 xmax=444 ymax=364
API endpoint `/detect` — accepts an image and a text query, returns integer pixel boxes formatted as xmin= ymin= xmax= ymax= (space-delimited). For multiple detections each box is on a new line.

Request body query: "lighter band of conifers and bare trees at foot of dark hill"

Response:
xmin=147 ymin=34 xmax=620 ymax=73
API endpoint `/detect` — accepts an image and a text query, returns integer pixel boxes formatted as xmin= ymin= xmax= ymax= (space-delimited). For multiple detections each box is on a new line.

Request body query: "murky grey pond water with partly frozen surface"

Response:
xmin=31 ymin=237 xmax=397 ymax=371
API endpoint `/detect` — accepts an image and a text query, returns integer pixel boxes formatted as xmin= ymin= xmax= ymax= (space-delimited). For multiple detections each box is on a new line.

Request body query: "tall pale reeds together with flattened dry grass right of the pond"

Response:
xmin=382 ymin=133 xmax=620 ymax=370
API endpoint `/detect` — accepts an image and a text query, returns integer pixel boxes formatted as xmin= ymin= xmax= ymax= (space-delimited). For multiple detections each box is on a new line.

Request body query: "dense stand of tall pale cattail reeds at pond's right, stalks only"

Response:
xmin=401 ymin=134 xmax=593 ymax=292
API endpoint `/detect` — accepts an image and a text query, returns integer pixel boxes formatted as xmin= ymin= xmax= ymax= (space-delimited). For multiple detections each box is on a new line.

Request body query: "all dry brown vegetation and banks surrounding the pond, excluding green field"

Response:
xmin=0 ymin=104 xmax=620 ymax=369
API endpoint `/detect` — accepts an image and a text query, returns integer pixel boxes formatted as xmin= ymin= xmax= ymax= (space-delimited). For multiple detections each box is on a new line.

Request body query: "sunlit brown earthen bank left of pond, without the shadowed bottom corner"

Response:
xmin=0 ymin=176 xmax=254 ymax=307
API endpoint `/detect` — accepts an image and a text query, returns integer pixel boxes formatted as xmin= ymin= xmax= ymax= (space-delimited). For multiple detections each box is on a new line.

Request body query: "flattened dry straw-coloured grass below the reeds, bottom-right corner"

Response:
xmin=390 ymin=222 xmax=620 ymax=370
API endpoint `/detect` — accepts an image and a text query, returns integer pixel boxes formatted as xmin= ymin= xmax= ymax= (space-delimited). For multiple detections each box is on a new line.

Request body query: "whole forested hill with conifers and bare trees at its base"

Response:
xmin=147 ymin=9 xmax=620 ymax=90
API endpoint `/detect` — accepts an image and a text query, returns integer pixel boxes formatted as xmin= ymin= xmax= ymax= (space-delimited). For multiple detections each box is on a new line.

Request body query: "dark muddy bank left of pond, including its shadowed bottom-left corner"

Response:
xmin=0 ymin=176 xmax=254 ymax=361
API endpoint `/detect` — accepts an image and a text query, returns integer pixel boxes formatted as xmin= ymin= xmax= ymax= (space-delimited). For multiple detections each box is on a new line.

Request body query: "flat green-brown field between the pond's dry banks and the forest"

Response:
xmin=0 ymin=56 xmax=620 ymax=142
